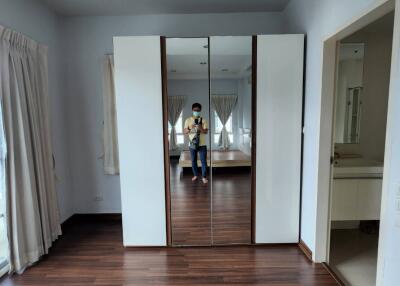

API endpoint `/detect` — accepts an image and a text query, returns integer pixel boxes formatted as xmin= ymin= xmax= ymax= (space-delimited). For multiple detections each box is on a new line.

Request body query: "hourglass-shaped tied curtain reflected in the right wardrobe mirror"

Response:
xmin=211 ymin=95 xmax=237 ymax=150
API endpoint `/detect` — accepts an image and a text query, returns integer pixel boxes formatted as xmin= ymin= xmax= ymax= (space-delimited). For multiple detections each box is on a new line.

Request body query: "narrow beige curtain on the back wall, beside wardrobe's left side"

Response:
xmin=103 ymin=55 xmax=119 ymax=175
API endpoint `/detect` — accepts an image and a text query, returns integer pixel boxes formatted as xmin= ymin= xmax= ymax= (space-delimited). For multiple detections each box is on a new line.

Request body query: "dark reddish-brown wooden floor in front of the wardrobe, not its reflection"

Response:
xmin=0 ymin=218 xmax=337 ymax=286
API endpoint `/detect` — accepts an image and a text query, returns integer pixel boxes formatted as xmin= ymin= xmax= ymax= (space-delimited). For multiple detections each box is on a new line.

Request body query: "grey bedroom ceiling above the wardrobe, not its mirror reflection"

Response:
xmin=40 ymin=0 xmax=290 ymax=16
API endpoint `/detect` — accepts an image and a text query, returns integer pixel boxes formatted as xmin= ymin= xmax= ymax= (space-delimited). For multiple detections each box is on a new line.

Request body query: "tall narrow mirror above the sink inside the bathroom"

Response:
xmin=335 ymin=43 xmax=364 ymax=144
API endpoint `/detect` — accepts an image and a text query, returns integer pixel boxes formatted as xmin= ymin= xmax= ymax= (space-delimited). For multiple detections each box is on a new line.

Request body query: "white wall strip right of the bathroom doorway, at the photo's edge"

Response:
xmin=377 ymin=0 xmax=400 ymax=286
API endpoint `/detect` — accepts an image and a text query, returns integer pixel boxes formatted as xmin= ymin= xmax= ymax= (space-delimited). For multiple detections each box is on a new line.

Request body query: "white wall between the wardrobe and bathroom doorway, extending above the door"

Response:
xmin=284 ymin=0 xmax=390 ymax=255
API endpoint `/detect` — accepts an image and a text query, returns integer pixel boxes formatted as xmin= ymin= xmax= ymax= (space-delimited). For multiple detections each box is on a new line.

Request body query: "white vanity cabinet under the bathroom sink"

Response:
xmin=331 ymin=178 xmax=382 ymax=221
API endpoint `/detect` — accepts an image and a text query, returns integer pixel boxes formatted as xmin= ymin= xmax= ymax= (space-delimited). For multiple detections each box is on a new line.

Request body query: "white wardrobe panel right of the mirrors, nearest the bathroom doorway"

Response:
xmin=256 ymin=35 xmax=304 ymax=243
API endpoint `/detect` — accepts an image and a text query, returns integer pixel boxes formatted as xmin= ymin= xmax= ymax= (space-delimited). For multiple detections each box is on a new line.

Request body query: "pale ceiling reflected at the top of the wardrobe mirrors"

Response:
xmin=166 ymin=36 xmax=252 ymax=79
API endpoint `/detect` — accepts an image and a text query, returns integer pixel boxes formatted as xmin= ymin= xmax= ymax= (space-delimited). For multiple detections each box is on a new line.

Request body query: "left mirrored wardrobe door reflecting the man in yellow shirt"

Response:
xmin=166 ymin=38 xmax=211 ymax=246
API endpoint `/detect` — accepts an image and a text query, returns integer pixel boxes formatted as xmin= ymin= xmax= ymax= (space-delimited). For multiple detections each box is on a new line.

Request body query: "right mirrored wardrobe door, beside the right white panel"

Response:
xmin=210 ymin=36 xmax=252 ymax=245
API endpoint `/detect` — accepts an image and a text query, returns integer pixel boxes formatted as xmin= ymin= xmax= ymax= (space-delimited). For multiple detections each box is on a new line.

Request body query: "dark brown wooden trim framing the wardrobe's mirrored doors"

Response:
xmin=160 ymin=35 xmax=257 ymax=247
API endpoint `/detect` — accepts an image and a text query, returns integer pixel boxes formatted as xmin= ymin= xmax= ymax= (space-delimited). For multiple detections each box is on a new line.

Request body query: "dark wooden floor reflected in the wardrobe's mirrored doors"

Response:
xmin=170 ymin=161 xmax=251 ymax=246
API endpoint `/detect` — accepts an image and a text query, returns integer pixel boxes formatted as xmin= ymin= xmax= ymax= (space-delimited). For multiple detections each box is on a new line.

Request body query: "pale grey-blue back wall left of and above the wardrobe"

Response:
xmin=63 ymin=13 xmax=282 ymax=213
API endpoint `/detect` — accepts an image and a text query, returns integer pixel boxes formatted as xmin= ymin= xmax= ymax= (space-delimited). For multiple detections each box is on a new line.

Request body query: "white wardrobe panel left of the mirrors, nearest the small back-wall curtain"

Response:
xmin=114 ymin=36 xmax=167 ymax=246
